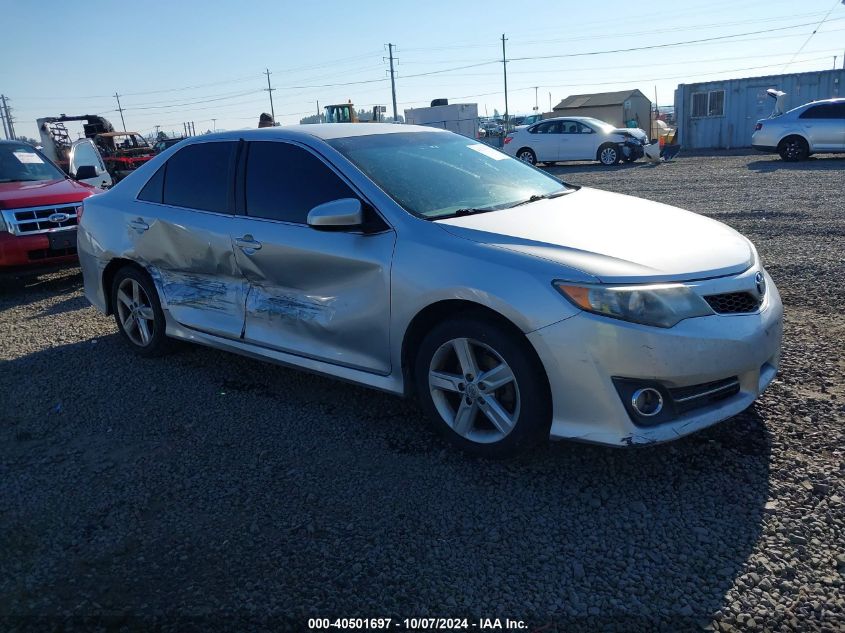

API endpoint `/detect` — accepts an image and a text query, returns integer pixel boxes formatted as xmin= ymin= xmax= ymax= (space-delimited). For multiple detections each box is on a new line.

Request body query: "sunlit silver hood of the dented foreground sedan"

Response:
xmin=437 ymin=188 xmax=754 ymax=283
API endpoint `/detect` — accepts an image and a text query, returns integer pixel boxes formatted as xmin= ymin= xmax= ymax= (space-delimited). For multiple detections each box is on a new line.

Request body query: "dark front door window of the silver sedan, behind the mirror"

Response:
xmin=245 ymin=142 xmax=358 ymax=224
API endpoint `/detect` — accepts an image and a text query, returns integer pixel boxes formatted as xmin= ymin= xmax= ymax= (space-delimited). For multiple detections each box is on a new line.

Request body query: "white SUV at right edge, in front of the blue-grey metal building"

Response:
xmin=751 ymin=98 xmax=845 ymax=161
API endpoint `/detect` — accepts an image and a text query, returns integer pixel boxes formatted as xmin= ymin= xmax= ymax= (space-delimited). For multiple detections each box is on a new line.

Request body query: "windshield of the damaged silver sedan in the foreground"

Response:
xmin=328 ymin=132 xmax=569 ymax=220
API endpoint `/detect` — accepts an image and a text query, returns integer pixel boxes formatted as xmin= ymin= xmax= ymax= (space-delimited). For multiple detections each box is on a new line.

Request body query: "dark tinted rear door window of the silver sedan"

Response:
xmin=162 ymin=141 xmax=238 ymax=213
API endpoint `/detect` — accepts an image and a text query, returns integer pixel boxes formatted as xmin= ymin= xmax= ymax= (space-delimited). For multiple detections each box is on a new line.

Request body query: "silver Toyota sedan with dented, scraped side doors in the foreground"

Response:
xmin=79 ymin=124 xmax=783 ymax=456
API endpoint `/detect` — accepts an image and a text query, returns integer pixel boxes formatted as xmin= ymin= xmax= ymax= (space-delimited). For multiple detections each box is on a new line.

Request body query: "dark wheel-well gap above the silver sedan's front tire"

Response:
xmin=401 ymin=299 xmax=548 ymax=396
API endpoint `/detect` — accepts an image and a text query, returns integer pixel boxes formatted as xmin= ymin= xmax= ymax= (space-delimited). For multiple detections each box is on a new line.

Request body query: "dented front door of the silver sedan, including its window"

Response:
xmin=232 ymin=141 xmax=395 ymax=374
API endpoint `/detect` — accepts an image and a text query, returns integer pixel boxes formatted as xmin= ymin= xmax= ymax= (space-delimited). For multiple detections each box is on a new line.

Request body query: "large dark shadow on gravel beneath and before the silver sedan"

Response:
xmin=0 ymin=335 xmax=771 ymax=630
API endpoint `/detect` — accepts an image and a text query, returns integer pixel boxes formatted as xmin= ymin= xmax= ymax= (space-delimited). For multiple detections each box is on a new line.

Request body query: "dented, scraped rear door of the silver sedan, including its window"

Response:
xmin=131 ymin=141 xmax=247 ymax=339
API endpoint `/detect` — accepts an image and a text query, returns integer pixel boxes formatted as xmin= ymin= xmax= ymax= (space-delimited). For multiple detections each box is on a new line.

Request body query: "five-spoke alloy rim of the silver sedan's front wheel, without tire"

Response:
xmin=428 ymin=338 xmax=520 ymax=444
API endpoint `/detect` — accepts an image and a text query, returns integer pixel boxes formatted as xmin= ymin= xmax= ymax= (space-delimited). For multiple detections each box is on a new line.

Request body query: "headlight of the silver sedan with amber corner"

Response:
xmin=553 ymin=281 xmax=713 ymax=327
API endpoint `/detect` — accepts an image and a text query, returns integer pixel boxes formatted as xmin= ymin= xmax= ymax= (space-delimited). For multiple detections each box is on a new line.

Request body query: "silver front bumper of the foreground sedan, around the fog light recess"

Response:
xmin=528 ymin=274 xmax=783 ymax=446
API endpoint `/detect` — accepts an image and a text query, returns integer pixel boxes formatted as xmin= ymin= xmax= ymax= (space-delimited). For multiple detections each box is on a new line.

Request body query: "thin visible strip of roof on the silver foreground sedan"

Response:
xmin=177 ymin=123 xmax=450 ymax=142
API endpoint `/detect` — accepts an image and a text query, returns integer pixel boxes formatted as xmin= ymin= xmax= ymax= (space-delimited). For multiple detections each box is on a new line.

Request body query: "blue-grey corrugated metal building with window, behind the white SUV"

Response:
xmin=675 ymin=70 xmax=845 ymax=149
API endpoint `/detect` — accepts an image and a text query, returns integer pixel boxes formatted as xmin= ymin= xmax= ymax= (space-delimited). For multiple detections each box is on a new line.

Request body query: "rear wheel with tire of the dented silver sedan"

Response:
xmin=112 ymin=266 xmax=169 ymax=357
